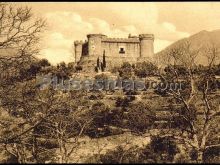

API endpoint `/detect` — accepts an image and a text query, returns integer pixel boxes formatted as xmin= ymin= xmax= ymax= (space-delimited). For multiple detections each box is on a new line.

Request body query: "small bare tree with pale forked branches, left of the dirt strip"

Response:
xmin=40 ymin=94 xmax=93 ymax=163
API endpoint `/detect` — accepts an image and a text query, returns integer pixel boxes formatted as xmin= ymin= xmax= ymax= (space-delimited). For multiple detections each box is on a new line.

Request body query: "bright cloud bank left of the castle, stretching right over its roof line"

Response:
xmin=39 ymin=12 xmax=142 ymax=64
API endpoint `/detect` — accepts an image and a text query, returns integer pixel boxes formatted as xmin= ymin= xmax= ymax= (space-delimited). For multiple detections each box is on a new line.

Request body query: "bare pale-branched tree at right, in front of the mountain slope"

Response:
xmin=159 ymin=42 xmax=220 ymax=162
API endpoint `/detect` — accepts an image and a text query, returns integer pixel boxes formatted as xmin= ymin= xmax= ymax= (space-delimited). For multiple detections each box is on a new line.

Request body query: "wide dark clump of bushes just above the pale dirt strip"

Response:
xmin=86 ymin=102 xmax=155 ymax=137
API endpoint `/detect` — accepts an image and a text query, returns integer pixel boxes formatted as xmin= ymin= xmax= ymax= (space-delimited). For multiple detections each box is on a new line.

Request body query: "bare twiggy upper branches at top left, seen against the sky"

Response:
xmin=0 ymin=3 xmax=45 ymax=55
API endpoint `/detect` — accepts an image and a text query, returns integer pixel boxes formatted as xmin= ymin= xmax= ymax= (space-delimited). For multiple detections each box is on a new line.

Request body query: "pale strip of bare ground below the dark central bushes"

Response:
xmin=55 ymin=133 xmax=150 ymax=163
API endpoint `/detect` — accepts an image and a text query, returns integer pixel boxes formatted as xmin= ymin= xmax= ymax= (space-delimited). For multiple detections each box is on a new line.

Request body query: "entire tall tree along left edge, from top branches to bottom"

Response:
xmin=0 ymin=3 xmax=47 ymax=163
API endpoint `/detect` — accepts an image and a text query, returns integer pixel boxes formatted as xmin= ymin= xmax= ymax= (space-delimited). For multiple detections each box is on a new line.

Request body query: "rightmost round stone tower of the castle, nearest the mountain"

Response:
xmin=139 ymin=34 xmax=154 ymax=60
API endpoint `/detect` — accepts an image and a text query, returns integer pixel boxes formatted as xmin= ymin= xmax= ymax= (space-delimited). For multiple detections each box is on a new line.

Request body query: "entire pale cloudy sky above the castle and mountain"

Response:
xmin=15 ymin=2 xmax=220 ymax=64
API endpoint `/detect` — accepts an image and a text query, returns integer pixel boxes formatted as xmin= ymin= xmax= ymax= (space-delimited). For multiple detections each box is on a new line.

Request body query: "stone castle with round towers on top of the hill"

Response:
xmin=74 ymin=34 xmax=154 ymax=69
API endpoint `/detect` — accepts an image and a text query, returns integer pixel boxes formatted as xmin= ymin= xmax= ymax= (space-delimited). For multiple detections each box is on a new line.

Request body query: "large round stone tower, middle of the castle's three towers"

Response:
xmin=87 ymin=34 xmax=107 ymax=56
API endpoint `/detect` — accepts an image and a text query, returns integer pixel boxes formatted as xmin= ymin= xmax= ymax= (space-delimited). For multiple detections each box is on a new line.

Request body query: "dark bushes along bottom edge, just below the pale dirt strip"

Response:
xmin=95 ymin=136 xmax=179 ymax=164
